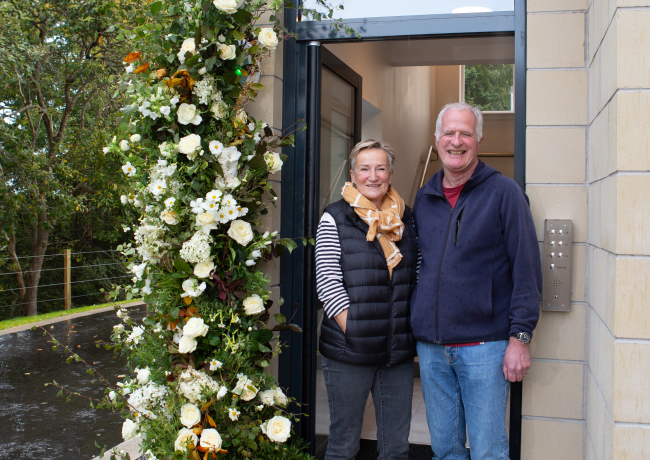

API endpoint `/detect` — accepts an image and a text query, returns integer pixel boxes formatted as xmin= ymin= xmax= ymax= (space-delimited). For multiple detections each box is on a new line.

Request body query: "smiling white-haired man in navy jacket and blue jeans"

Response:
xmin=411 ymin=103 xmax=542 ymax=460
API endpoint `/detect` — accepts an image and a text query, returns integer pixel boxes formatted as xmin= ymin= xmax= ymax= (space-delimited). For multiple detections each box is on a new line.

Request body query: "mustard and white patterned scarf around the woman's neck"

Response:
xmin=341 ymin=182 xmax=404 ymax=279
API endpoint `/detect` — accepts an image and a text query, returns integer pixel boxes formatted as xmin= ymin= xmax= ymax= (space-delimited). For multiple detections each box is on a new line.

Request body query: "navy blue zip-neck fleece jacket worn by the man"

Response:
xmin=411 ymin=161 xmax=542 ymax=344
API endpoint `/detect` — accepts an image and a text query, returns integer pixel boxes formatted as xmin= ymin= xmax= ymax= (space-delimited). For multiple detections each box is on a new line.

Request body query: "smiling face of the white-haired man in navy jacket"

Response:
xmin=436 ymin=110 xmax=483 ymax=175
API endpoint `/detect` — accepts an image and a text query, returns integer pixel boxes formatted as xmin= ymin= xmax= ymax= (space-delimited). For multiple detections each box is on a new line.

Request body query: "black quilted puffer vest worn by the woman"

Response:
xmin=319 ymin=200 xmax=417 ymax=366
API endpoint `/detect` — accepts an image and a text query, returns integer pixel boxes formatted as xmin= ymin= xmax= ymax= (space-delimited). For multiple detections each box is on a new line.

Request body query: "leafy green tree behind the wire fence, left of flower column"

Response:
xmin=0 ymin=0 xmax=137 ymax=315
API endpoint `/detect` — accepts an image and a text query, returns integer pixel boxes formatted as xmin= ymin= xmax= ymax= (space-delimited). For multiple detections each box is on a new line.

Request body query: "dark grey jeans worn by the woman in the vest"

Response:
xmin=323 ymin=356 xmax=413 ymax=460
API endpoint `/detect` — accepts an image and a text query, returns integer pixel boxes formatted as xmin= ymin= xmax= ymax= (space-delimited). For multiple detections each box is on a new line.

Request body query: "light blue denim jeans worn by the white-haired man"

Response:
xmin=418 ymin=340 xmax=510 ymax=460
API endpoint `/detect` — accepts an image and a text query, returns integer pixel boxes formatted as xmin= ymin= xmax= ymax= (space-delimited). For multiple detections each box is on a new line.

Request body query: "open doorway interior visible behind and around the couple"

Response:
xmin=312 ymin=35 xmax=515 ymax=452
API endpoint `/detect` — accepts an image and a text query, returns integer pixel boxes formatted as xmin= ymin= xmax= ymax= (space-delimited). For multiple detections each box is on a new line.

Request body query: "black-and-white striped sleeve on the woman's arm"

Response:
xmin=316 ymin=212 xmax=350 ymax=318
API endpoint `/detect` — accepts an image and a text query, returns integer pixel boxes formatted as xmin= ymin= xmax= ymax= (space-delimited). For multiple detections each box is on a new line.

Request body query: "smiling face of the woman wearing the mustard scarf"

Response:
xmin=350 ymin=149 xmax=393 ymax=208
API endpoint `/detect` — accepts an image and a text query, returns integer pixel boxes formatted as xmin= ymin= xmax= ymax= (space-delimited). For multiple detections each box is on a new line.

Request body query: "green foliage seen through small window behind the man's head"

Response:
xmin=465 ymin=64 xmax=514 ymax=111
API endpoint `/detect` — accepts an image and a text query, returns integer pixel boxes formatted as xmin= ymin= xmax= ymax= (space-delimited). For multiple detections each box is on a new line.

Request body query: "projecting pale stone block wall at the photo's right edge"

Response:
xmin=585 ymin=0 xmax=650 ymax=460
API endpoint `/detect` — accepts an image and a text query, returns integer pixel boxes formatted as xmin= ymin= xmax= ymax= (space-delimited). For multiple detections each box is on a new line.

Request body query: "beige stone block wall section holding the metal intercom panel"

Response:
xmin=521 ymin=0 xmax=590 ymax=460
